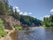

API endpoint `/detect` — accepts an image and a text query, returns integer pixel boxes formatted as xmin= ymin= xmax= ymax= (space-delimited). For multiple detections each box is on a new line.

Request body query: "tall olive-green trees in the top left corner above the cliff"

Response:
xmin=0 ymin=0 xmax=9 ymax=15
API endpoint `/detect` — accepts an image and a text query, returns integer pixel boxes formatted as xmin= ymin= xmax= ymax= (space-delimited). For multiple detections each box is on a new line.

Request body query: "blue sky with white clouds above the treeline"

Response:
xmin=9 ymin=0 xmax=53 ymax=20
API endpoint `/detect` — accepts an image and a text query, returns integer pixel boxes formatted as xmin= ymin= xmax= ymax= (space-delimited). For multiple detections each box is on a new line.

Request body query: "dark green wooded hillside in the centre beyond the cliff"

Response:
xmin=20 ymin=15 xmax=41 ymax=26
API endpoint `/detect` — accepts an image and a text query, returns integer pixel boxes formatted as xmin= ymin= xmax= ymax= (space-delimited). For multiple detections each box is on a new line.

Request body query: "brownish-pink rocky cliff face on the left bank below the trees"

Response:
xmin=0 ymin=15 xmax=21 ymax=29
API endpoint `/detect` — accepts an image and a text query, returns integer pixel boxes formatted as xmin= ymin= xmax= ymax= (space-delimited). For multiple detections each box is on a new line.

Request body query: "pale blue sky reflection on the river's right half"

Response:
xmin=33 ymin=28 xmax=45 ymax=40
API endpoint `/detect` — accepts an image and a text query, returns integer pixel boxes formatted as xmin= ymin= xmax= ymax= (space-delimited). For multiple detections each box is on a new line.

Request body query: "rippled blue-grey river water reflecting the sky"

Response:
xmin=10 ymin=27 xmax=53 ymax=40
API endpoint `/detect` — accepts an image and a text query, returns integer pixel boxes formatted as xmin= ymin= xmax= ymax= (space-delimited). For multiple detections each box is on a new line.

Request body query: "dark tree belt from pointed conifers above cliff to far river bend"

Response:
xmin=9 ymin=2 xmax=42 ymax=26
